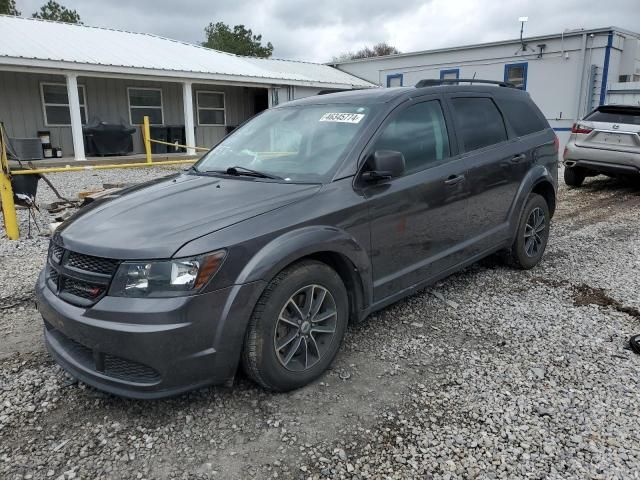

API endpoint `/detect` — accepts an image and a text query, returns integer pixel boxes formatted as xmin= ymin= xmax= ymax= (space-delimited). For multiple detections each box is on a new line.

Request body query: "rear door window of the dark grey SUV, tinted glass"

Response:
xmin=451 ymin=97 xmax=507 ymax=152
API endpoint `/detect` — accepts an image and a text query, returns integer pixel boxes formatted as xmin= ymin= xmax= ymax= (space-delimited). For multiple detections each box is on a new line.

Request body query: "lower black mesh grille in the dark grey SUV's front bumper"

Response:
xmin=47 ymin=324 xmax=162 ymax=384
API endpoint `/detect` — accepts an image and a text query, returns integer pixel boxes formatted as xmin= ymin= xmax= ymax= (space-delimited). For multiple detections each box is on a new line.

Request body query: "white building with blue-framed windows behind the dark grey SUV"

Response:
xmin=334 ymin=27 xmax=640 ymax=142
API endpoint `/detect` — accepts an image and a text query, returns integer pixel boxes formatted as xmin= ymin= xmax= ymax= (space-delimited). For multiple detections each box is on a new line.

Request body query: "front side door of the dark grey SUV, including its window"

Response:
xmin=360 ymin=96 xmax=468 ymax=301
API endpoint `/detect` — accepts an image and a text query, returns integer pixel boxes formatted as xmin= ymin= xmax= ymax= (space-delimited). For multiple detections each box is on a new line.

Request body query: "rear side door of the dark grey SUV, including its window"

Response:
xmin=448 ymin=93 xmax=532 ymax=256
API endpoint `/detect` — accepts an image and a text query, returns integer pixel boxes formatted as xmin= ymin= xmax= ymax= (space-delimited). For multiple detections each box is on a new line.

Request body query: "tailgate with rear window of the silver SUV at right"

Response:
xmin=574 ymin=105 xmax=640 ymax=154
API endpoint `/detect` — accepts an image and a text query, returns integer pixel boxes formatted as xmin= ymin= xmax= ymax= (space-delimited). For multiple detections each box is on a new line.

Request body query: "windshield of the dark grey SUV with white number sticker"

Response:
xmin=194 ymin=104 xmax=370 ymax=183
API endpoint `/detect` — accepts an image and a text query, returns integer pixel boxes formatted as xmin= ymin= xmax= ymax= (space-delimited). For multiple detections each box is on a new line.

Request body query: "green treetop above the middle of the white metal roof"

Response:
xmin=202 ymin=22 xmax=273 ymax=58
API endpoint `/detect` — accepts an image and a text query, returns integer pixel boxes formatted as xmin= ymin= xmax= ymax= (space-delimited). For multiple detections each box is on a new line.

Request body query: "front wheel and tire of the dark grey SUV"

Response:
xmin=242 ymin=260 xmax=349 ymax=392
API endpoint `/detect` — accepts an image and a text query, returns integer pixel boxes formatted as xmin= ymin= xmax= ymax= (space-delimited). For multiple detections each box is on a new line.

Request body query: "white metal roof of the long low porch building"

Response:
xmin=0 ymin=15 xmax=374 ymax=88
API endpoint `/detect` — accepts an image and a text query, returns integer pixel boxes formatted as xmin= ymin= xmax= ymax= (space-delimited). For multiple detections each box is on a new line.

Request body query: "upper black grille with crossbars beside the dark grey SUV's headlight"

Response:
xmin=46 ymin=235 xmax=118 ymax=307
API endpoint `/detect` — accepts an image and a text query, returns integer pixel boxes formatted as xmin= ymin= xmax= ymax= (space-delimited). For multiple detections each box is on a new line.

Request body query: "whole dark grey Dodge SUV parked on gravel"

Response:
xmin=36 ymin=80 xmax=558 ymax=398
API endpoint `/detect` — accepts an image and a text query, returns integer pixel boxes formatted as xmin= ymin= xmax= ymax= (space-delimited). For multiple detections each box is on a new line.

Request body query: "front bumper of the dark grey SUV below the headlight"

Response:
xmin=36 ymin=274 xmax=264 ymax=399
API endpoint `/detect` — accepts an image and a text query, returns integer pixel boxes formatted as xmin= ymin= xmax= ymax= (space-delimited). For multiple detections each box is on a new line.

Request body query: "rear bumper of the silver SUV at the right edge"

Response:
xmin=563 ymin=142 xmax=640 ymax=175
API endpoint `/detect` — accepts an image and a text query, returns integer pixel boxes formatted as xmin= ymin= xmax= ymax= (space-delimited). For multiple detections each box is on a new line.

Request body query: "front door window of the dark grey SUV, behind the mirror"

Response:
xmin=374 ymin=100 xmax=449 ymax=174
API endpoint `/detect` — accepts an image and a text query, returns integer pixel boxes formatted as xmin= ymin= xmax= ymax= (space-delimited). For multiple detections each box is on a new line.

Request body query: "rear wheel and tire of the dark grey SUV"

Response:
xmin=509 ymin=193 xmax=551 ymax=270
